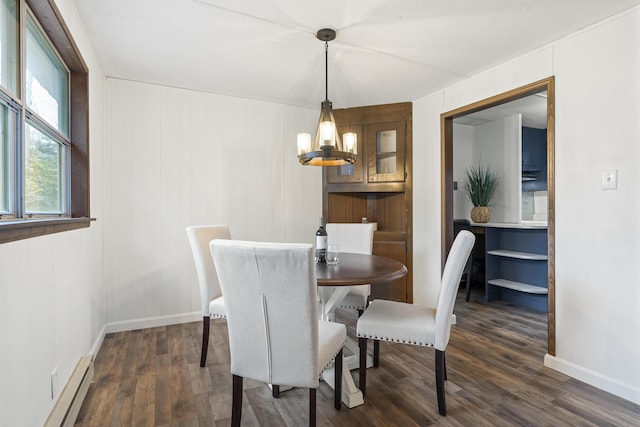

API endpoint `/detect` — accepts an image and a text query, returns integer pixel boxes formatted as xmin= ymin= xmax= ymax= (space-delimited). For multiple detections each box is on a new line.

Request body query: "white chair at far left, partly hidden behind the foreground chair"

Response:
xmin=187 ymin=225 xmax=231 ymax=367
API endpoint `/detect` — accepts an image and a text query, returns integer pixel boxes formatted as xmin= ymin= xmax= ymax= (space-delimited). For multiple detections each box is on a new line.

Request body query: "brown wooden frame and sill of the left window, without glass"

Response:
xmin=0 ymin=0 xmax=95 ymax=243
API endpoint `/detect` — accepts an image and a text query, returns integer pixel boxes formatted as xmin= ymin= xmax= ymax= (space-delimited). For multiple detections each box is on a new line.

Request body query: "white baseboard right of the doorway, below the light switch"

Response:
xmin=544 ymin=354 xmax=640 ymax=404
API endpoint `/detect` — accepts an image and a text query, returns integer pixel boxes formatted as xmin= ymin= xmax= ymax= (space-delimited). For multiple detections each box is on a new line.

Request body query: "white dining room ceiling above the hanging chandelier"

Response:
xmin=75 ymin=0 xmax=640 ymax=109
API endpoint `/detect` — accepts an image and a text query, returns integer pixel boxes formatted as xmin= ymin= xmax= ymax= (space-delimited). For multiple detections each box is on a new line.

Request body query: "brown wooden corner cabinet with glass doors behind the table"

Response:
xmin=323 ymin=103 xmax=413 ymax=302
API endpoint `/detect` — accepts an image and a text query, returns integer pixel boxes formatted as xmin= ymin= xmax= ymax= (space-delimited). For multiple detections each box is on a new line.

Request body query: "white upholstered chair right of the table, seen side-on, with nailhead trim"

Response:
xmin=357 ymin=230 xmax=476 ymax=415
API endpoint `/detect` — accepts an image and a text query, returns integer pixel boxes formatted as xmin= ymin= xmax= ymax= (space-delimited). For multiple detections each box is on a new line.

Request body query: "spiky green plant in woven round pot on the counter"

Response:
xmin=464 ymin=165 xmax=500 ymax=223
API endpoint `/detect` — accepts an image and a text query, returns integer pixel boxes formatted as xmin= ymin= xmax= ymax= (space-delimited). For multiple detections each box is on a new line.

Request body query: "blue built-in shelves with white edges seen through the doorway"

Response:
xmin=485 ymin=224 xmax=548 ymax=312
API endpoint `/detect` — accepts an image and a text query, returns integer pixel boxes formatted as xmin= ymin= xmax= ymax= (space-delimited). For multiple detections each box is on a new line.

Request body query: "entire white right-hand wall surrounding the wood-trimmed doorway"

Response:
xmin=413 ymin=8 xmax=640 ymax=403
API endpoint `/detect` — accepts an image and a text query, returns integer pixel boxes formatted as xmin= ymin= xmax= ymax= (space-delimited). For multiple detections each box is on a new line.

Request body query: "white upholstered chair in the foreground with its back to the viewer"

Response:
xmin=210 ymin=240 xmax=347 ymax=426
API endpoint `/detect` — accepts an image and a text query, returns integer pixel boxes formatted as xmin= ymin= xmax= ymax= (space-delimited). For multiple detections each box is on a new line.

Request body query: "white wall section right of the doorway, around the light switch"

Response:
xmin=552 ymin=8 xmax=640 ymax=403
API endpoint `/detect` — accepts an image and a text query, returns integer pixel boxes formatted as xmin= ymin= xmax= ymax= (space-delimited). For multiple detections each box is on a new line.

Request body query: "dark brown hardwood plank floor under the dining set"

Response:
xmin=76 ymin=288 xmax=640 ymax=426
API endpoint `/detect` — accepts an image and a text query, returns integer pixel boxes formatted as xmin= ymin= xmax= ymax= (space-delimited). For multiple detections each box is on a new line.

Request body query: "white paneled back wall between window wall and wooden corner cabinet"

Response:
xmin=106 ymin=79 xmax=322 ymax=331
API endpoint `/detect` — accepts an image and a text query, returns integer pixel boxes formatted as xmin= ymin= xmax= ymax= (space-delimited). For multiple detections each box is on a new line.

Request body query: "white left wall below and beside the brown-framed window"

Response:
xmin=0 ymin=0 xmax=106 ymax=426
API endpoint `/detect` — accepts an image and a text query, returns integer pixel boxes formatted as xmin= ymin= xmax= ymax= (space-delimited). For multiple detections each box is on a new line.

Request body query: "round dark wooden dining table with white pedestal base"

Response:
xmin=316 ymin=252 xmax=407 ymax=408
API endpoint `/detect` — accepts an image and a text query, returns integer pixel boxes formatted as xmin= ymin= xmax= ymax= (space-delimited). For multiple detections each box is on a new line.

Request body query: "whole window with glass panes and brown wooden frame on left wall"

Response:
xmin=0 ymin=0 xmax=90 ymax=243
